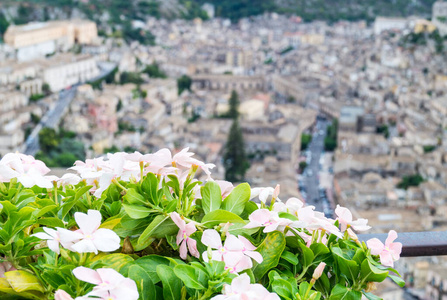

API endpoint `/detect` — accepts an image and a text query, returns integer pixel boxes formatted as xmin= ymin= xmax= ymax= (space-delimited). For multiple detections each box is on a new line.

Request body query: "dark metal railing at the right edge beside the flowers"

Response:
xmin=358 ymin=231 xmax=447 ymax=257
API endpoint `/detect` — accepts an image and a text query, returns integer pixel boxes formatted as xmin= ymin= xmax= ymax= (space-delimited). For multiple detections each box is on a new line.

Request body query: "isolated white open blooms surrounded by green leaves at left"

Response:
xmin=34 ymin=210 xmax=120 ymax=254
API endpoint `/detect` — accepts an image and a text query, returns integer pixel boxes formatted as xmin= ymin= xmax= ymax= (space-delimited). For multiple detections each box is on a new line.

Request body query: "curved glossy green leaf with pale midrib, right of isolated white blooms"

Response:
xmin=135 ymin=215 xmax=178 ymax=251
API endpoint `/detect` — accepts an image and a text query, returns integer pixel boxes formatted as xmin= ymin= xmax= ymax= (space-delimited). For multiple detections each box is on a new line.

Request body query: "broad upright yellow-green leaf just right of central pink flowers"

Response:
xmin=253 ymin=231 xmax=286 ymax=281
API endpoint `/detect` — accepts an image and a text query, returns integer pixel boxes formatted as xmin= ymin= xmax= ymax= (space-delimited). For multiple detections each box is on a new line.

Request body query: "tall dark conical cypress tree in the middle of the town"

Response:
xmin=224 ymin=119 xmax=250 ymax=182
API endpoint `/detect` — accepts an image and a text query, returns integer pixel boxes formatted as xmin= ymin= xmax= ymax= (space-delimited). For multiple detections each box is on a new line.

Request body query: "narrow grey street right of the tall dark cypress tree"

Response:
xmin=303 ymin=120 xmax=332 ymax=217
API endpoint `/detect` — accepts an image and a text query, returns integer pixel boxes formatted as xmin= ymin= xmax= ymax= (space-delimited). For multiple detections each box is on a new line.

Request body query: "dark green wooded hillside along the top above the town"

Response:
xmin=0 ymin=0 xmax=435 ymax=30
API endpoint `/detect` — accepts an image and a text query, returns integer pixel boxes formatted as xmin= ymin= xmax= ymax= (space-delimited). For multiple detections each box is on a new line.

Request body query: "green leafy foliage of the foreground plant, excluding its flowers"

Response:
xmin=0 ymin=146 xmax=404 ymax=300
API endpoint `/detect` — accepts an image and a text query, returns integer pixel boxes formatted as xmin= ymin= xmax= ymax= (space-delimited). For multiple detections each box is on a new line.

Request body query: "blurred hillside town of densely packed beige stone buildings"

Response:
xmin=0 ymin=1 xmax=447 ymax=299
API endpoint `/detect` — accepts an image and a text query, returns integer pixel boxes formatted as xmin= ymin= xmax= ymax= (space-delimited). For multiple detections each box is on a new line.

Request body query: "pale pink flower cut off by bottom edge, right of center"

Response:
xmin=211 ymin=274 xmax=280 ymax=300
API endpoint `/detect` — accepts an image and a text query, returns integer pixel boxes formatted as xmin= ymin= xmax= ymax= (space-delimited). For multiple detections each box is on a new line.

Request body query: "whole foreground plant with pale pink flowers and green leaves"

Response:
xmin=0 ymin=148 xmax=403 ymax=300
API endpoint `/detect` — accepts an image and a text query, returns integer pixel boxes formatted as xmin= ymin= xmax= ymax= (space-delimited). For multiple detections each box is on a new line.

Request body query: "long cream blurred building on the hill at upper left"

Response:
xmin=4 ymin=20 xmax=98 ymax=61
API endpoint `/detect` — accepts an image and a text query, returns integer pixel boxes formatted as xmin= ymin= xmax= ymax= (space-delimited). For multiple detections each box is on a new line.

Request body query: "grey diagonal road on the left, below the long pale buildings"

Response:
xmin=20 ymin=63 xmax=116 ymax=156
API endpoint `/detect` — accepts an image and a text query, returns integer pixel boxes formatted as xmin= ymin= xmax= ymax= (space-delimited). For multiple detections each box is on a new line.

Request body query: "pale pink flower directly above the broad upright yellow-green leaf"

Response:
xmin=244 ymin=209 xmax=292 ymax=233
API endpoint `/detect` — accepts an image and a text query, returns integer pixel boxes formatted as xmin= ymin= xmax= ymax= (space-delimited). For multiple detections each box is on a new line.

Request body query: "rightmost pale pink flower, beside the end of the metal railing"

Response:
xmin=366 ymin=230 xmax=402 ymax=267
